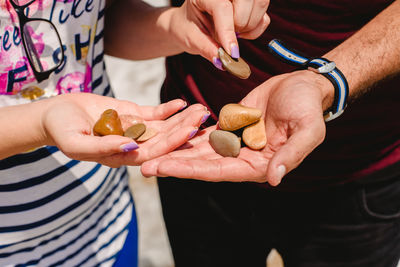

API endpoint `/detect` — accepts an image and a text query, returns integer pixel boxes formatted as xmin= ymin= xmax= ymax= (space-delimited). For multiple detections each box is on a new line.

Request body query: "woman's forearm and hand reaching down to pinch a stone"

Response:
xmin=105 ymin=0 xmax=269 ymax=61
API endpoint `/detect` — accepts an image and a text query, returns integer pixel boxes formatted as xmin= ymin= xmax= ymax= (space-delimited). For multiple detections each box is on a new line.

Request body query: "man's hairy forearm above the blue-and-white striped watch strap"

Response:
xmin=324 ymin=1 xmax=400 ymax=108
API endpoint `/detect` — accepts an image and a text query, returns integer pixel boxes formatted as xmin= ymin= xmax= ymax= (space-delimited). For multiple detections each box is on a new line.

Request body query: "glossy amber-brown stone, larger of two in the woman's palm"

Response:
xmin=93 ymin=109 xmax=124 ymax=136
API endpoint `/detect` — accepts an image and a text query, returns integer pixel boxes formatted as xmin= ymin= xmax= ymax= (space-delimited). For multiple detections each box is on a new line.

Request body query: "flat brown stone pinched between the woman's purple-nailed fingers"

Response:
xmin=218 ymin=47 xmax=251 ymax=79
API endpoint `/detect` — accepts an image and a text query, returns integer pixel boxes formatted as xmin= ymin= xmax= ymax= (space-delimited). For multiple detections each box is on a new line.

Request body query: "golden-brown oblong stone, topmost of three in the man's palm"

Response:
xmin=219 ymin=104 xmax=262 ymax=131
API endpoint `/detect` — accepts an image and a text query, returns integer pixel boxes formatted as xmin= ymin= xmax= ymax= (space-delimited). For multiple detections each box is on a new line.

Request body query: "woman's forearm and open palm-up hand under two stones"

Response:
xmin=0 ymin=93 xmax=207 ymax=167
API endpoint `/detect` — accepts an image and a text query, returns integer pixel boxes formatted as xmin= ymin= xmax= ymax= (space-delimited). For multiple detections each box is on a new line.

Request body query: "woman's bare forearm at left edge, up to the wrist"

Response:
xmin=0 ymin=101 xmax=47 ymax=159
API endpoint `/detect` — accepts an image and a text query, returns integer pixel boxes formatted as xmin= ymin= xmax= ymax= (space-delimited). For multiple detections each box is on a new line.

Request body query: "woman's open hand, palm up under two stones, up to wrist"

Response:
xmin=42 ymin=93 xmax=208 ymax=167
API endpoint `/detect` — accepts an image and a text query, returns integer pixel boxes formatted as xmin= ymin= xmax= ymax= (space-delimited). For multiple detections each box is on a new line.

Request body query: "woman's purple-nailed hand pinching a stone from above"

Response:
xmin=169 ymin=0 xmax=270 ymax=67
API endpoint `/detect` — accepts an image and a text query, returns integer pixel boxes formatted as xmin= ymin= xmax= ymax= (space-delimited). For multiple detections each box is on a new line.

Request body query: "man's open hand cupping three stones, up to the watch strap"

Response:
xmin=141 ymin=71 xmax=333 ymax=186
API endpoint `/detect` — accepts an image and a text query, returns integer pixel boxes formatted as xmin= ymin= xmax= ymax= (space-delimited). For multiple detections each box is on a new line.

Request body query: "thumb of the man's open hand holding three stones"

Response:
xmin=267 ymin=121 xmax=325 ymax=186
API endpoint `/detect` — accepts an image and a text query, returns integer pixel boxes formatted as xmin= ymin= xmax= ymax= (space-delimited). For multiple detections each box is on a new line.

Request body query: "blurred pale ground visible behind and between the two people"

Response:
xmin=105 ymin=0 xmax=283 ymax=267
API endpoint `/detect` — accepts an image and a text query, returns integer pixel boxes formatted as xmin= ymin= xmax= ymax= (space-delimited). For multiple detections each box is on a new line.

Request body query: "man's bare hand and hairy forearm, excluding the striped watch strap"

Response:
xmin=141 ymin=1 xmax=400 ymax=186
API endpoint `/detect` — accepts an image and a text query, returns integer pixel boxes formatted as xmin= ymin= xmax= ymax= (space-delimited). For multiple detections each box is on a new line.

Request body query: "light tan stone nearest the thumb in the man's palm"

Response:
xmin=242 ymin=119 xmax=267 ymax=150
